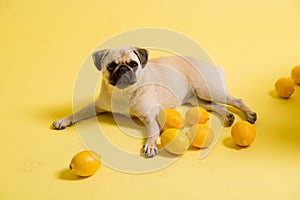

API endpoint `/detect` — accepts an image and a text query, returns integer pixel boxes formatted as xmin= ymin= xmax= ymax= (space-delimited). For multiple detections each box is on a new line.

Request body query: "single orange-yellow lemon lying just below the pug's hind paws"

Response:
xmin=231 ymin=121 xmax=256 ymax=147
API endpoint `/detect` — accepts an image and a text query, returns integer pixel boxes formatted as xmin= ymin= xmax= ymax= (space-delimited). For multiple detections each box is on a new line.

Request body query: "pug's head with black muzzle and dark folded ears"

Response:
xmin=93 ymin=47 xmax=148 ymax=89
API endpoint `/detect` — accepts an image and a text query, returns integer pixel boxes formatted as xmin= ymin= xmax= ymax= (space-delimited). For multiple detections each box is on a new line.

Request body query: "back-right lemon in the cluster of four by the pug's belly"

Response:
xmin=185 ymin=107 xmax=209 ymax=126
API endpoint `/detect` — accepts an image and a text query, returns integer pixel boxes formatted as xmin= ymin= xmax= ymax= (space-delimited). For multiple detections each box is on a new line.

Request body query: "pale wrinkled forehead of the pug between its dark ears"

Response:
xmin=103 ymin=48 xmax=139 ymax=64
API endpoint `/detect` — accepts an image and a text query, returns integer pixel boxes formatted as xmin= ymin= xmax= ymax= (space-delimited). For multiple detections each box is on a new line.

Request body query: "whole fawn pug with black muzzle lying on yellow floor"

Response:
xmin=52 ymin=47 xmax=257 ymax=157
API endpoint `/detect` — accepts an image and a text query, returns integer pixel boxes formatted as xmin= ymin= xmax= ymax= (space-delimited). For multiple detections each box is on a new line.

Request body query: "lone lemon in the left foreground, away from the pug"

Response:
xmin=69 ymin=151 xmax=101 ymax=177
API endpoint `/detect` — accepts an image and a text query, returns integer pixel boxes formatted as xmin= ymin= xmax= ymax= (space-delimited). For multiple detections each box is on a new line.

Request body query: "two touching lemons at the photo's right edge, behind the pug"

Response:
xmin=275 ymin=65 xmax=300 ymax=99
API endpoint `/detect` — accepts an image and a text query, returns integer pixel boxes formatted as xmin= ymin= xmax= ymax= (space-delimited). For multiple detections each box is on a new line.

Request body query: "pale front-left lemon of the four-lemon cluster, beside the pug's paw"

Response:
xmin=160 ymin=128 xmax=190 ymax=155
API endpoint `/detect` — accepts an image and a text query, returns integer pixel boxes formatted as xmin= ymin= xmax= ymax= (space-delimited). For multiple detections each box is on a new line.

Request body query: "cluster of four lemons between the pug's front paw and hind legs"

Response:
xmin=157 ymin=107 xmax=214 ymax=155
